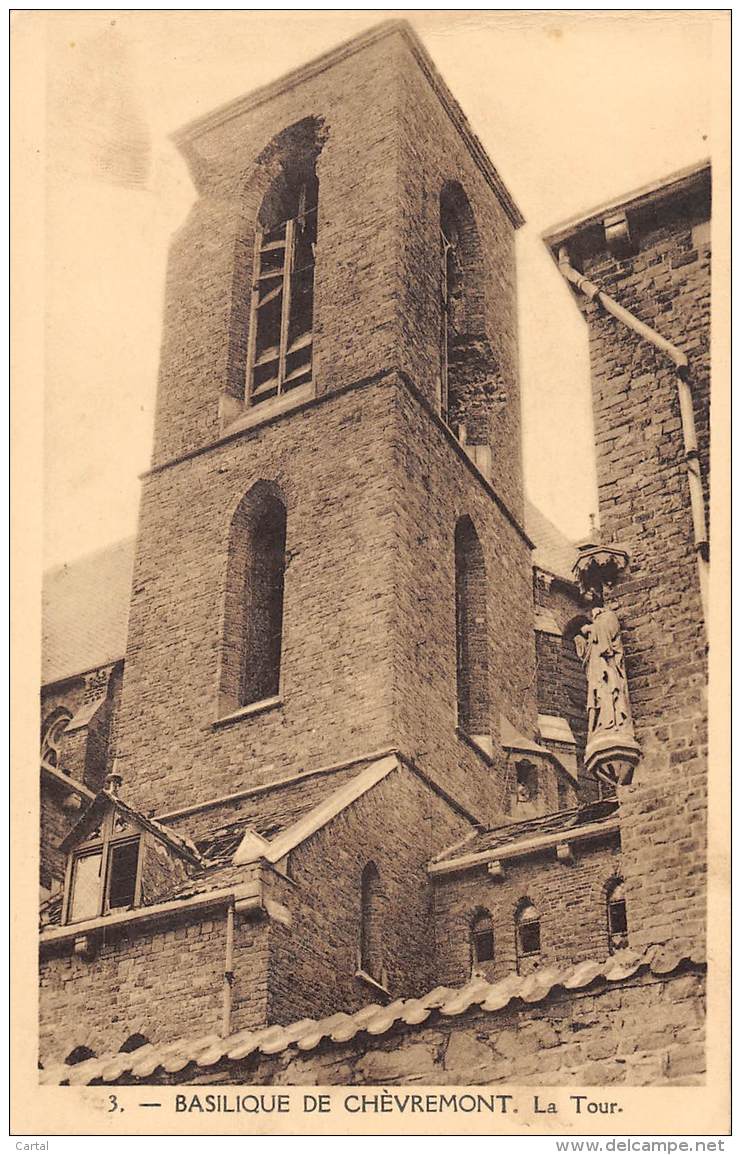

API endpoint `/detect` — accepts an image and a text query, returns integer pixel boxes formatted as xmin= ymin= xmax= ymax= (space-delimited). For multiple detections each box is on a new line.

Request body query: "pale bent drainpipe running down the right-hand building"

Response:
xmin=559 ymin=245 xmax=710 ymax=623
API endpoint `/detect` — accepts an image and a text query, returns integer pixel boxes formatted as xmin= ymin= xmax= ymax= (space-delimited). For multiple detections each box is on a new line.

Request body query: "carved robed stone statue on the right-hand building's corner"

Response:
xmin=574 ymin=606 xmax=633 ymax=738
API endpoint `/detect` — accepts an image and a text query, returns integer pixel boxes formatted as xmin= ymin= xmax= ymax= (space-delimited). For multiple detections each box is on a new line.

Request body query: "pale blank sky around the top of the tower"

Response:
xmin=39 ymin=10 xmax=725 ymax=566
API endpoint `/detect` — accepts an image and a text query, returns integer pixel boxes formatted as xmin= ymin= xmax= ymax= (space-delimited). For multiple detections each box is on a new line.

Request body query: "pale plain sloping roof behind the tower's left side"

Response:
xmin=42 ymin=538 xmax=135 ymax=685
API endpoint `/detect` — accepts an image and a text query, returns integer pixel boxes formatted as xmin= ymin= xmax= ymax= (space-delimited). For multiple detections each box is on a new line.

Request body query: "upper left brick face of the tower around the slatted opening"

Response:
xmin=154 ymin=28 xmax=398 ymax=463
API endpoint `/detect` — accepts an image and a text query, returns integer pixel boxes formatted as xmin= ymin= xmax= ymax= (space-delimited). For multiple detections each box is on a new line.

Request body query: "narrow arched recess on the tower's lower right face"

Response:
xmin=455 ymin=516 xmax=491 ymax=737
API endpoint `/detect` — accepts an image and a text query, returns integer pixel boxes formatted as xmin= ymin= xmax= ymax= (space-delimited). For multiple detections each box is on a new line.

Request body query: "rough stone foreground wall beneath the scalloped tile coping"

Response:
xmin=150 ymin=968 xmax=705 ymax=1094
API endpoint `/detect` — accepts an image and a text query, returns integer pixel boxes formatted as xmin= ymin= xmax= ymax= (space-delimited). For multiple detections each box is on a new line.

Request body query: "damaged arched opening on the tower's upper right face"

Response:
xmin=440 ymin=181 xmax=493 ymax=445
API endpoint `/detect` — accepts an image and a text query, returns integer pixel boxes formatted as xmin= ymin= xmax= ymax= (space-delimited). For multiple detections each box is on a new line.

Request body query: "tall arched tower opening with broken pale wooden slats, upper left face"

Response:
xmin=246 ymin=119 xmax=319 ymax=405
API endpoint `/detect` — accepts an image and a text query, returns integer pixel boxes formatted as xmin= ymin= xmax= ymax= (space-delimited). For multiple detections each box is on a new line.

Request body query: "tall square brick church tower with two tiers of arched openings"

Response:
xmin=118 ymin=22 xmax=537 ymax=821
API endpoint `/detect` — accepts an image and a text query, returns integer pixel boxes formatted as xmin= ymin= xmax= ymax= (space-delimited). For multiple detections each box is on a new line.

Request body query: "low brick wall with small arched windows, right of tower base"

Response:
xmin=432 ymin=836 xmax=618 ymax=986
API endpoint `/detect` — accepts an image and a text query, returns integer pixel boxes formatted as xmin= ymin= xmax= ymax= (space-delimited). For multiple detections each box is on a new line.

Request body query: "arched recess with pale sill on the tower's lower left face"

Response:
xmin=219 ymin=482 xmax=286 ymax=714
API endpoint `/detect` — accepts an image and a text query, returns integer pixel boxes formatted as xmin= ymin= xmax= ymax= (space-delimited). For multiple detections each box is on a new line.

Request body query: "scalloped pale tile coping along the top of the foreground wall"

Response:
xmin=39 ymin=947 xmax=704 ymax=1086
